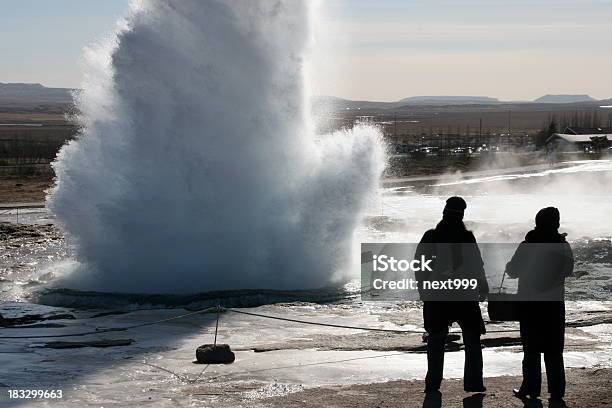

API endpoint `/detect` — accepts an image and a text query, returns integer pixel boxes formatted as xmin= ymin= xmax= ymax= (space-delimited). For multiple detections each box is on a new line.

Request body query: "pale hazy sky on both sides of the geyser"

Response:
xmin=0 ymin=0 xmax=612 ymax=101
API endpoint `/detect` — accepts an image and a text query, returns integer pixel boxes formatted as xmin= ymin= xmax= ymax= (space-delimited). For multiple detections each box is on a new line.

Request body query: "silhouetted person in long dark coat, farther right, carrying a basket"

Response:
xmin=506 ymin=207 xmax=574 ymax=406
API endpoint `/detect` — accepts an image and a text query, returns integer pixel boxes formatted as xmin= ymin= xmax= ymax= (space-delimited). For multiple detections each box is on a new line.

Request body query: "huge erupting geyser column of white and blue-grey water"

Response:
xmin=48 ymin=0 xmax=383 ymax=293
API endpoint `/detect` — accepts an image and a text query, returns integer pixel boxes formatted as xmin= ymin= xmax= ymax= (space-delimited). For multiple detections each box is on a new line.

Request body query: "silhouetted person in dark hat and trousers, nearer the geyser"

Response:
xmin=415 ymin=197 xmax=489 ymax=393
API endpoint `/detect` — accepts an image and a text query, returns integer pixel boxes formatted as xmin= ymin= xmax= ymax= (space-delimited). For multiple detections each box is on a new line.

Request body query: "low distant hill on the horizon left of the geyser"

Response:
xmin=0 ymin=82 xmax=72 ymax=106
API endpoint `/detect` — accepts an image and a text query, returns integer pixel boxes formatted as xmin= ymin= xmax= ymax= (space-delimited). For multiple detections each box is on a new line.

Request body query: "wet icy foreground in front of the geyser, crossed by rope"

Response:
xmin=0 ymin=302 xmax=612 ymax=407
